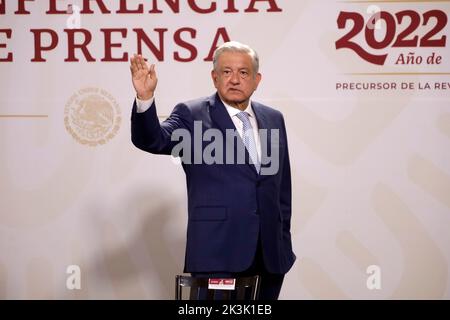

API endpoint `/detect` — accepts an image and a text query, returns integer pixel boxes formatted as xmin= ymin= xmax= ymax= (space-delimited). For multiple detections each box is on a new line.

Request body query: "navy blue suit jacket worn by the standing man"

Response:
xmin=131 ymin=93 xmax=295 ymax=274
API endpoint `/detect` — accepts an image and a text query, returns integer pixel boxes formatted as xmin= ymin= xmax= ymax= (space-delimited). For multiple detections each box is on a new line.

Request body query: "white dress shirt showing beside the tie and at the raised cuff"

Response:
xmin=136 ymin=96 xmax=261 ymax=163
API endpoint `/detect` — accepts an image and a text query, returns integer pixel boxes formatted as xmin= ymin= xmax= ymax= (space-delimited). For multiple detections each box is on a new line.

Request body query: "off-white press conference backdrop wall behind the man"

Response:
xmin=0 ymin=0 xmax=450 ymax=299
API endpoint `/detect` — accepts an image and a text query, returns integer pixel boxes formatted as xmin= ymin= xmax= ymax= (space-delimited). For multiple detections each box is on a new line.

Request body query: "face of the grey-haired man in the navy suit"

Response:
xmin=211 ymin=51 xmax=261 ymax=110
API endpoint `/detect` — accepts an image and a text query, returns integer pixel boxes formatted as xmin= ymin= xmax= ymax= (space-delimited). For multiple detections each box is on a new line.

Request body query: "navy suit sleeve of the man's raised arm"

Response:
xmin=131 ymin=101 xmax=192 ymax=155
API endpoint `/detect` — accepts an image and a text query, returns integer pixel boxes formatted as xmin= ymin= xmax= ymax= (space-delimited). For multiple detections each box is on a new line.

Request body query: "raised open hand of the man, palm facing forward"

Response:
xmin=130 ymin=54 xmax=158 ymax=100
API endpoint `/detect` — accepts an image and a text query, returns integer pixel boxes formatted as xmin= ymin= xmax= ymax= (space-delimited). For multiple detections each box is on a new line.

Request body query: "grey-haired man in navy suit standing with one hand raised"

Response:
xmin=130 ymin=42 xmax=295 ymax=299
